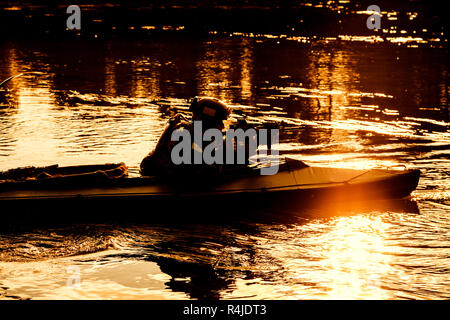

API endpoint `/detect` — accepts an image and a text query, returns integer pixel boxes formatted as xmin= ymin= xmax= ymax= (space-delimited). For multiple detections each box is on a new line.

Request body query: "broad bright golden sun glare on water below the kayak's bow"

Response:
xmin=224 ymin=212 xmax=417 ymax=299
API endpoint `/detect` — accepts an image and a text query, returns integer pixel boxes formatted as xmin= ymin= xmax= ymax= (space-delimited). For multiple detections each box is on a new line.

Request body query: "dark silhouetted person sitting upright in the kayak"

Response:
xmin=140 ymin=97 xmax=230 ymax=180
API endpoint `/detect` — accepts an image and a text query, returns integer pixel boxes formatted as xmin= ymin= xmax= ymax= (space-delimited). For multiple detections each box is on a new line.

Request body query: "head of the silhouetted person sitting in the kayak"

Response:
xmin=189 ymin=97 xmax=231 ymax=130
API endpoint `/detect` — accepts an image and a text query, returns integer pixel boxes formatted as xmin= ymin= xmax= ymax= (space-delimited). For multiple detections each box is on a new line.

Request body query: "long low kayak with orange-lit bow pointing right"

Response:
xmin=0 ymin=160 xmax=420 ymax=209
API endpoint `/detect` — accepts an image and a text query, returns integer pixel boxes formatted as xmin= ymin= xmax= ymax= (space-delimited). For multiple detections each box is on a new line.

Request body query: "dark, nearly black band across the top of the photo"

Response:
xmin=0 ymin=1 xmax=446 ymax=40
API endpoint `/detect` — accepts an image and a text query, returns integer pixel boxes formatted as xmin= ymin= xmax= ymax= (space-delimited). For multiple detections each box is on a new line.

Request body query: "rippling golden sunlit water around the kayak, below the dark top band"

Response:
xmin=0 ymin=1 xmax=450 ymax=299
